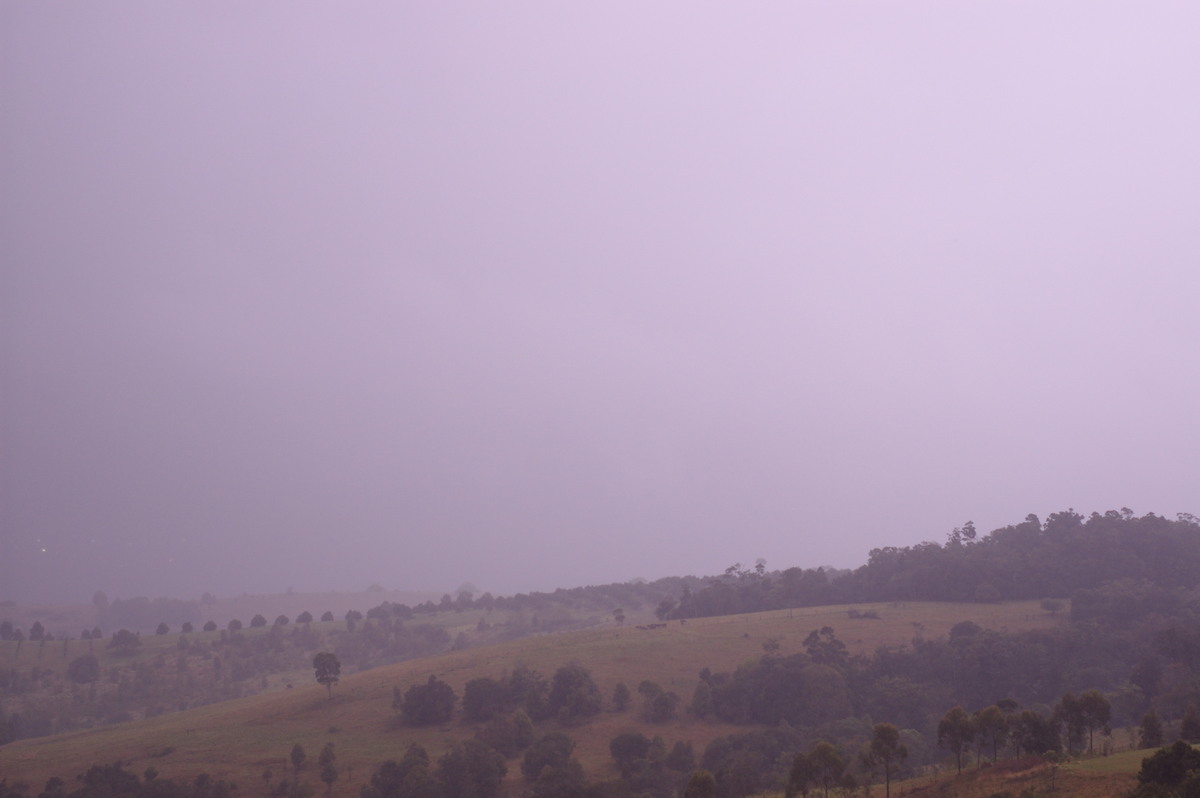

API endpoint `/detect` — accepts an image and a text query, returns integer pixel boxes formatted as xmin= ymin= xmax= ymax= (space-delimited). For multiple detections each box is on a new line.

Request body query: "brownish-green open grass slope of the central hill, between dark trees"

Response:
xmin=0 ymin=601 xmax=1075 ymax=796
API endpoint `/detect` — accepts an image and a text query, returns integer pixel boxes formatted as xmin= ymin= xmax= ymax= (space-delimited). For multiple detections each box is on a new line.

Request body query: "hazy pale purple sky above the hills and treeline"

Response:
xmin=0 ymin=0 xmax=1200 ymax=600
